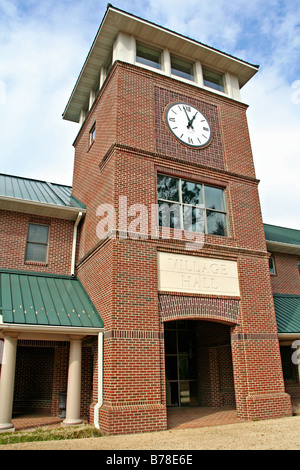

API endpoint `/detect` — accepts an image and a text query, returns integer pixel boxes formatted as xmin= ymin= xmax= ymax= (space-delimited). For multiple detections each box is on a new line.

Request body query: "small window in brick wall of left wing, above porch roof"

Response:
xmin=25 ymin=224 xmax=49 ymax=263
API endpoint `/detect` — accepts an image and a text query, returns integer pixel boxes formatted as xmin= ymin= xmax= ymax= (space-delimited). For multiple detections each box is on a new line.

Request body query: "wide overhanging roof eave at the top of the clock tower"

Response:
xmin=63 ymin=4 xmax=259 ymax=122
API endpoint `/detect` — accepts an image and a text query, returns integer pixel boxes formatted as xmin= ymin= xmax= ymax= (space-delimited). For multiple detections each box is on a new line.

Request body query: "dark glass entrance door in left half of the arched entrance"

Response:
xmin=165 ymin=320 xmax=198 ymax=406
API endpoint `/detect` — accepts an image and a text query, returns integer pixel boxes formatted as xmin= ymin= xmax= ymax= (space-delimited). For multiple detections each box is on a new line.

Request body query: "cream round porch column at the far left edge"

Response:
xmin=0 ymin=335 xmax=18 ymax=432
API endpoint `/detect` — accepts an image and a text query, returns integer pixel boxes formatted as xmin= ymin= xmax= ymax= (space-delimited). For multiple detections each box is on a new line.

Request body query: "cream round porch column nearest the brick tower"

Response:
xmin=63 ymin=337 xmax=82 ymax=425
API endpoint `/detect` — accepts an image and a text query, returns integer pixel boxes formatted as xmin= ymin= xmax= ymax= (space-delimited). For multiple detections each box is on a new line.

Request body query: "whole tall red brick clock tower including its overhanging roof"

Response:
xmin=63 ymin=5 xmax=291 ymax=433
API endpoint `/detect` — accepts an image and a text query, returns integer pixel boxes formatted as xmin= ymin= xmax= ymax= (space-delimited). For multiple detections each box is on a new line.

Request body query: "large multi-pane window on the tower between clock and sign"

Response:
xmin=157 ymin=175 xmax=227 ymax=236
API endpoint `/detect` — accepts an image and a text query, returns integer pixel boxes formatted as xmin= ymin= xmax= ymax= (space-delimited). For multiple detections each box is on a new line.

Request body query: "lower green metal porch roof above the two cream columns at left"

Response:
xmin=0 ymin=270 xmax=103 ymax=328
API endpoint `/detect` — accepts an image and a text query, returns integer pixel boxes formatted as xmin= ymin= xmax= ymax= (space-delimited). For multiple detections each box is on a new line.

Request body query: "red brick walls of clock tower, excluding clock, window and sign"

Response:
xmin=73 ymin=63 xmax=291 ymax=433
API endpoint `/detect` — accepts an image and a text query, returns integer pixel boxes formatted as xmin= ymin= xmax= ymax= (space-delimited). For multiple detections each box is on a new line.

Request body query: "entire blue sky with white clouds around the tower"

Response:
xmin=0 ymin=0 xmax=300 ymax=230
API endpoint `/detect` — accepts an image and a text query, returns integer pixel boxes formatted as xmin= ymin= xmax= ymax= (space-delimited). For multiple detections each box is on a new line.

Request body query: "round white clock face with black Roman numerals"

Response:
xmin=166 ymin=102 xmax=212 ymax=148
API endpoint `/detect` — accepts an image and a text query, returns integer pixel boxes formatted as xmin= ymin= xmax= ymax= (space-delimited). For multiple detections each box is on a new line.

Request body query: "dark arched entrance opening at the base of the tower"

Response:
xmin=164 ymin=320 xmax=235 ymax=408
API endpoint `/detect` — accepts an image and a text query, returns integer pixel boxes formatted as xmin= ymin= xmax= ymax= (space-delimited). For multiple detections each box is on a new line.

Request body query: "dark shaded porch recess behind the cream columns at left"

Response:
xmin=13 ymin=339 xmax=94 ymax=421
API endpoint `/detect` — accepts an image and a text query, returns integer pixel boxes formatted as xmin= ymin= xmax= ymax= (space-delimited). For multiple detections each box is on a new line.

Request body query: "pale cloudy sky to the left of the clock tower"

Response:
xmin=0 ymin=1 xmax=106 ymax=184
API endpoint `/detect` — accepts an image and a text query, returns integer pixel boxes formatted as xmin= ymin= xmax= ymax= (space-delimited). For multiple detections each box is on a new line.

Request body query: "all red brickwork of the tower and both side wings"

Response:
xmin=0 ymin=58 xmax=300 ymax=434
